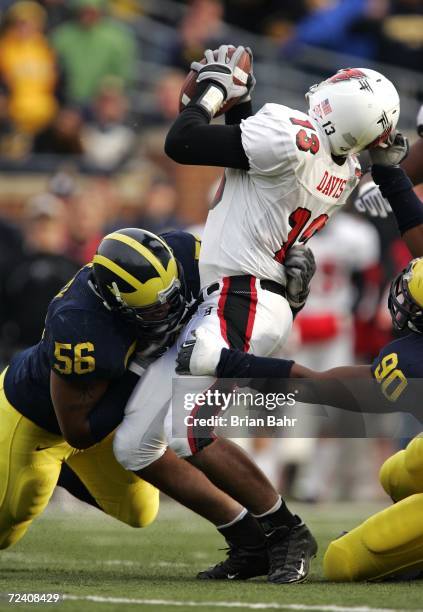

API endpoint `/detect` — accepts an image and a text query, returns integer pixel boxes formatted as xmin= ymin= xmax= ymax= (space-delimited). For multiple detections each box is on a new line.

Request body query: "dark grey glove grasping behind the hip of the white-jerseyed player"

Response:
xmin=284 ymin=245 xmax=316 ymax=308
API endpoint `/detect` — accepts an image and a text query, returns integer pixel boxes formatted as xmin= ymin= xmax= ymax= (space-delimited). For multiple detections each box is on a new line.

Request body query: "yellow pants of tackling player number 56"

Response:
xmin=0 ymin=372 xmax=159 ymax=549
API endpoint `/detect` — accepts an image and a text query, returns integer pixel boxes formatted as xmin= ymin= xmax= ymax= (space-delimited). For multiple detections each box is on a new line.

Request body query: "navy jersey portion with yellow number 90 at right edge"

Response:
xmin=371 ymin=332 xmax=423 ymax=402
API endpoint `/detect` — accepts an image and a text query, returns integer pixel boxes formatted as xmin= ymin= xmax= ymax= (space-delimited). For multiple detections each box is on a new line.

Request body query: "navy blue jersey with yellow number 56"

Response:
xmin=4 ymin=231 xmax=200 ymax=434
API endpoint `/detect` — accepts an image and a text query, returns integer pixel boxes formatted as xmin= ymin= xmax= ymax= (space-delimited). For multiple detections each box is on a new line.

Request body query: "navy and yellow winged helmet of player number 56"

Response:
xmin=92 ymin=228 xmax=190 ymax=341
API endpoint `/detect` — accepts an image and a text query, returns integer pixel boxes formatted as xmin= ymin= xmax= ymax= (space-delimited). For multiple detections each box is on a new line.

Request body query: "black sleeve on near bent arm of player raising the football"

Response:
xmin=165 ymin=83 xmax=250 ymax=170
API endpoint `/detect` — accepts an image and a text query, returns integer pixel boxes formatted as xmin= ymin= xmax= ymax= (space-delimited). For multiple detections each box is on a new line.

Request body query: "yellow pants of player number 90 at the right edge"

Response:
xmin=323 ymin=435 xmax=423 ymax=581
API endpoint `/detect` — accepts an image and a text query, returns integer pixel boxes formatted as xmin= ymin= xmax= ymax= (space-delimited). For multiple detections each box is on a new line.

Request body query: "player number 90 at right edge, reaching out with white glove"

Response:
xmin=179 ymin=134 xmax=423 ymax=581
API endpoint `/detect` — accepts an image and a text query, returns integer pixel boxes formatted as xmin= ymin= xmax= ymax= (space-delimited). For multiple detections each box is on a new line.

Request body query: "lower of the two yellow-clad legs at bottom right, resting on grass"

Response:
xmin=323 ymin=494 xmax=423 ymax=581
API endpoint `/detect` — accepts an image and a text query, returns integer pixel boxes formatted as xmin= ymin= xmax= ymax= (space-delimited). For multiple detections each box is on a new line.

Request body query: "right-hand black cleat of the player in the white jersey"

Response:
xmin=266 ymin=517 xmax=317 ymax=584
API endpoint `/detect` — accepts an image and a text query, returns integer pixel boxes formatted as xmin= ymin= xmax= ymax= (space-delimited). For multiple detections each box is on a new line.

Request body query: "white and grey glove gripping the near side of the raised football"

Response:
xmin=191 ymin=45 xmax=248 ymax=102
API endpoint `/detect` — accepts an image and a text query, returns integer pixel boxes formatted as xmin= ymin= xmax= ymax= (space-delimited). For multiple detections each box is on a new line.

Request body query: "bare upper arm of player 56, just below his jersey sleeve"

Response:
xmin=50 ymin=371 xmax=109 ymax=449
